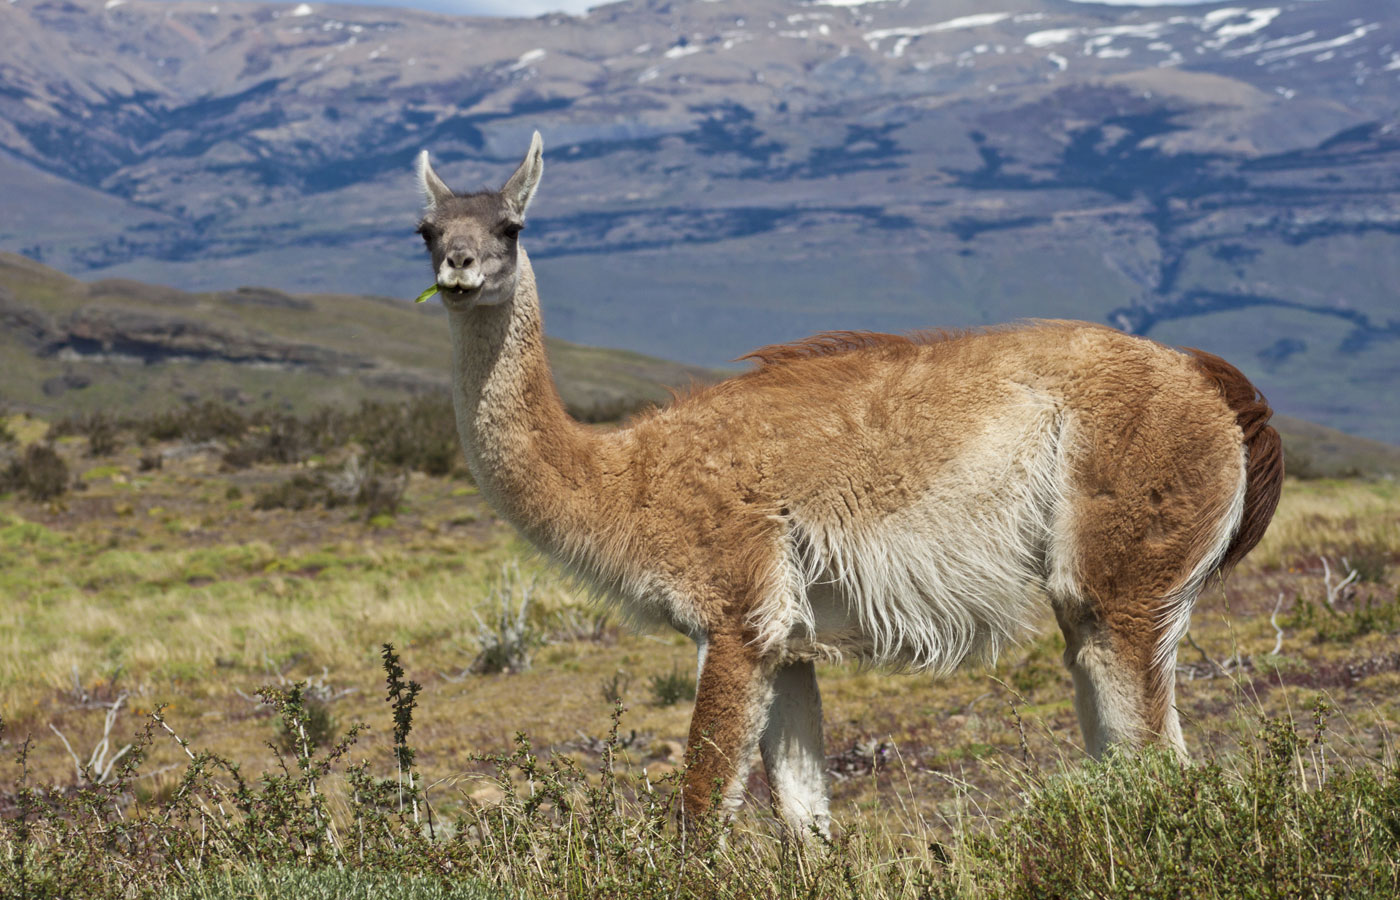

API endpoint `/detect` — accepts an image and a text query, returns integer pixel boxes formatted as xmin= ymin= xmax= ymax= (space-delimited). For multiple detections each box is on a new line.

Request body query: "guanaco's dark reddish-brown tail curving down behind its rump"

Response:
xmin=1187 ymin=349 xmax=1284 ymax=572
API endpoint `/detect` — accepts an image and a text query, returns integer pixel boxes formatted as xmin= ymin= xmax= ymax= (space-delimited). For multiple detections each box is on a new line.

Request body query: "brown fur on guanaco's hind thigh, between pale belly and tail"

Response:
xmin=1030 ymin=332 xmax=1239 ymax=735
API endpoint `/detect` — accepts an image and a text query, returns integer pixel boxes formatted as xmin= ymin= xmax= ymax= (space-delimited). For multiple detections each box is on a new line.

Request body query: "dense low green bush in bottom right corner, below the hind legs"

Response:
xmin=963 ymin=701 xmax=1400 ymax=900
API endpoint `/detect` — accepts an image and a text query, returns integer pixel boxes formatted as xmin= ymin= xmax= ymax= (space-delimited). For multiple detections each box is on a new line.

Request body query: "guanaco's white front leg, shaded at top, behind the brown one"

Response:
xmin=759 ymin=661 xmax=832 ymax=837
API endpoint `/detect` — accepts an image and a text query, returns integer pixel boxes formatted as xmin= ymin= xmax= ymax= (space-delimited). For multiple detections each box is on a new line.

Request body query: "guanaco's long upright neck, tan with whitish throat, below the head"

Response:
xmin=449 ymin=249 xmax=608 ymax=554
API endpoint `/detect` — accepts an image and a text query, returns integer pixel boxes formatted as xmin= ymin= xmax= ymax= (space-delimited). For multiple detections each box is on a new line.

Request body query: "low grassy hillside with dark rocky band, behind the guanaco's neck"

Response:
xmin=0 ymin=253 xmax=715 ymax=417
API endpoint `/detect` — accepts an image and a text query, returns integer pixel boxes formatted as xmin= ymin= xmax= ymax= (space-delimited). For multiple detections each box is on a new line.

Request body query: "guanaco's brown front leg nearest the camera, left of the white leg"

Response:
xmin=682 ymin=631 xmax=773 ymax=822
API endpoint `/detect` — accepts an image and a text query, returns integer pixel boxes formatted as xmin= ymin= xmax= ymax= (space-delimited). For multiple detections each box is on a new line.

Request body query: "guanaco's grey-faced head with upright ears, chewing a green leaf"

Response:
xmin=419 ymin=132 xmax=545 ymax=308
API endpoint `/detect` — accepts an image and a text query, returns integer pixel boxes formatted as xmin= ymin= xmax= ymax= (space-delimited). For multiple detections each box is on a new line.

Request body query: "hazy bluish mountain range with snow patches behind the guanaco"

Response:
xmin=0 ymin=0 xmax=1400 ymax=442
